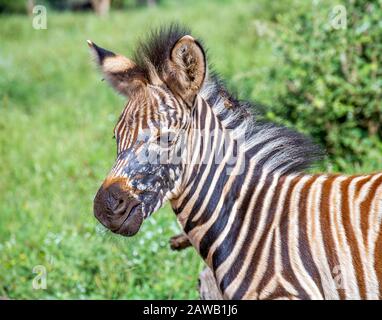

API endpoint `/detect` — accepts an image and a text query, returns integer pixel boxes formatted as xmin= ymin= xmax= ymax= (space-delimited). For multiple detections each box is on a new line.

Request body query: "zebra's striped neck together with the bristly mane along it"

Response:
xmin=171 ymin=75 xmax=318 ymax=287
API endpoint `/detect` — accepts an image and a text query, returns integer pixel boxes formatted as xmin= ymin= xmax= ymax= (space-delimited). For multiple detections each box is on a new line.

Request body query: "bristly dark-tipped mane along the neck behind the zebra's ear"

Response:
xmin=200 ymin=77 xmax=323 ymax=173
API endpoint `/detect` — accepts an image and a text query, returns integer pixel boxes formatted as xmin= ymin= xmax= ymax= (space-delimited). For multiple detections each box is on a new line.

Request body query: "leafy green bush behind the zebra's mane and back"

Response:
xmin=267 ymin=0 xmax=382 ymax=170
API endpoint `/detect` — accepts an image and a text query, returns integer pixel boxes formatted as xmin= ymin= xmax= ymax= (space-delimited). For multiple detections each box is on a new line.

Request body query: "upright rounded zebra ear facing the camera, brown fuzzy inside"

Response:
xmin=167 ymin=35 xmax=206 ymax=105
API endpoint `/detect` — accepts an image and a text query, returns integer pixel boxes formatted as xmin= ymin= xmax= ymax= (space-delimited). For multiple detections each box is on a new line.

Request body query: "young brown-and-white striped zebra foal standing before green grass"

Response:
xmin=88 ymin=25 xmax=382 ymax=300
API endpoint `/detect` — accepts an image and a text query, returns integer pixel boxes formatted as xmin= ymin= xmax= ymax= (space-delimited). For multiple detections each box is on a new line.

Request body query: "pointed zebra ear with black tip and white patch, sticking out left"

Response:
xmin=87 ymin=40 xmax=147 ymax=97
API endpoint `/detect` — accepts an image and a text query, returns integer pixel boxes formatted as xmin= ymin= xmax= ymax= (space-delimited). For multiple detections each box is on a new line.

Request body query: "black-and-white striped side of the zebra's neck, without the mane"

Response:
xmin=171 ymin=95 xmax=269 ymax=268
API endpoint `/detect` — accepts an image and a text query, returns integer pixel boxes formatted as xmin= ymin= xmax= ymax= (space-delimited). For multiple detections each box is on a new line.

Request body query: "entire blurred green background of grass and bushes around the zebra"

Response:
xmin=0 ymin=0 xmax=382 ymax=299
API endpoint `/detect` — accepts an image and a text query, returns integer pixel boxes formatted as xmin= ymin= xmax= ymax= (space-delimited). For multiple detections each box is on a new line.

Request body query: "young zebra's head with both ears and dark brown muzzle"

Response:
xmin=88 ymin=28 xmax=206 ymax=236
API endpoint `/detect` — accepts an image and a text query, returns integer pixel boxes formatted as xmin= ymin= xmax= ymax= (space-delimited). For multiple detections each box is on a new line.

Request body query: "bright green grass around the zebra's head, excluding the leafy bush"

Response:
xmin=0 ymin=0 xmax=376 ymax=299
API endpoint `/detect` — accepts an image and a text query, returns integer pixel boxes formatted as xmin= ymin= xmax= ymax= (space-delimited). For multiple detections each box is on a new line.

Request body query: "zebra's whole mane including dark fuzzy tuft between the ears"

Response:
xmin=134 ymin=24 xmax=323 ymax=173
